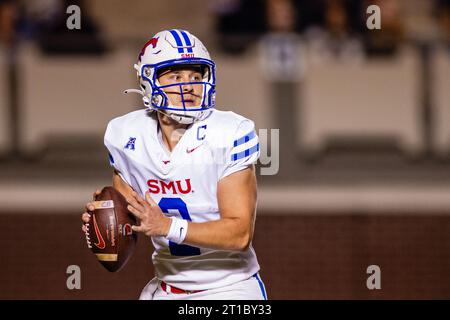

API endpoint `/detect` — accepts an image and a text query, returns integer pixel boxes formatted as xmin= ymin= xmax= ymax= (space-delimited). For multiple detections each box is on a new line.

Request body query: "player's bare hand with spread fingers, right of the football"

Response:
xmin=127 ymin=191 xmax=172 ymax=237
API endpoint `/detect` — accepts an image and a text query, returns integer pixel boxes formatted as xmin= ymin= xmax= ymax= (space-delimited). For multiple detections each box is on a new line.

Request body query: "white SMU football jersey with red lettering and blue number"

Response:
xmin=105 ymin=109 xmax=259 ymax=290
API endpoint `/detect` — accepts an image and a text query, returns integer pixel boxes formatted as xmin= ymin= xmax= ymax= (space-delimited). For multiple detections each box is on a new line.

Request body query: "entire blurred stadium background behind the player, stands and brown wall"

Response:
xmin=0 ymin=0 xmax=450 ymax=299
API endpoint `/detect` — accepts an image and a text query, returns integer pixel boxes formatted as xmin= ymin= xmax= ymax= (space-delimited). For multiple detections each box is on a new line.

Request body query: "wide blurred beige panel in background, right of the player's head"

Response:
xmin=297 ymin=48 xmax=424 ymax=155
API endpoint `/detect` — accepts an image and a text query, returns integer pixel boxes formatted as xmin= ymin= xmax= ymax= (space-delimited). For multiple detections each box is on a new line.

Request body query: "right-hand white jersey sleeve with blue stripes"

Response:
xmin=219 ymin=119 xmax=259 ymax=179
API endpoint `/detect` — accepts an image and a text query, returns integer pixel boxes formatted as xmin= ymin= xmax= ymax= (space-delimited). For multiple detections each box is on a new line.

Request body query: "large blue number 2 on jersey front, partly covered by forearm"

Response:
xmin=158 ymin=198 xmax=200 ymax=256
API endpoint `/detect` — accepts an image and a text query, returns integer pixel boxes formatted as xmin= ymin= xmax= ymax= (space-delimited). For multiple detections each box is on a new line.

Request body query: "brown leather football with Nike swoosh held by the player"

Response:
xmin=86 ymin=186 xmax=137 ymax=272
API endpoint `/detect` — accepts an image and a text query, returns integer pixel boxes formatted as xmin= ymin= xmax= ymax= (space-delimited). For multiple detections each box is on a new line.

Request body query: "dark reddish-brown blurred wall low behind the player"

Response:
xmin=0 ymin=212 xmax=450 ymax=299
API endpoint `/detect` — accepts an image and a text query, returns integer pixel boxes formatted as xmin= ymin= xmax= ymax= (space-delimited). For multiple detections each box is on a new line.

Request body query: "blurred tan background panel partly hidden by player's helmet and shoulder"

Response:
xmin=19 ymin=46 xmax=137 ymax=153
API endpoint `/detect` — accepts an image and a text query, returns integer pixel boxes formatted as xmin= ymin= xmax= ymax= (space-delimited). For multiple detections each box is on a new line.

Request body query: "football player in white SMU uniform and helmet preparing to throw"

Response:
xmin=82 ymin=29 xmax=267 ymax=300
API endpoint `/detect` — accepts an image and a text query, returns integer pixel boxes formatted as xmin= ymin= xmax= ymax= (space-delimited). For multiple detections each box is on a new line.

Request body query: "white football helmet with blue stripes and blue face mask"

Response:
xmin=125 ymin=29 xmax=216 ymax=124
